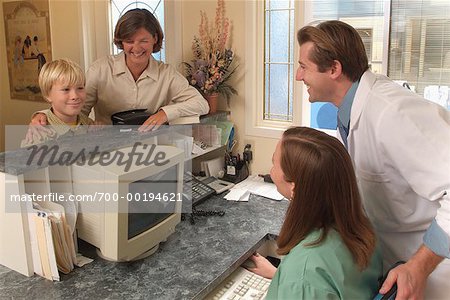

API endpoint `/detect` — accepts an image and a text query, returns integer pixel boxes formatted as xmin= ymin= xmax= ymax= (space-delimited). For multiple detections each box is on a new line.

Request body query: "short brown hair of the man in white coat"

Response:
xmin=297 ymin=20 xmax=369 ymax=82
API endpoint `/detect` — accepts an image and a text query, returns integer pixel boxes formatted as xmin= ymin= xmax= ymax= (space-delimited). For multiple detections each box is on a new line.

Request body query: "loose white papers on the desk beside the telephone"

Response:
xmin=224 ymin=175 xmax=284 ymax=201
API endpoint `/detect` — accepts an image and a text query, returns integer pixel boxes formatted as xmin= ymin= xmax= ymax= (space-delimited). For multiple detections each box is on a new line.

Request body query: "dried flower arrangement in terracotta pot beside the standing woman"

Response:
xmin=183 ymin=0 xmax=237 ymax=113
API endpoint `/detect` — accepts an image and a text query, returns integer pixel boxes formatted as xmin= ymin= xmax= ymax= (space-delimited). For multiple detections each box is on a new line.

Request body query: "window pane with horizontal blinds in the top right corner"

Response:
xmin=388 ymin=0 xmax=450 ymax=109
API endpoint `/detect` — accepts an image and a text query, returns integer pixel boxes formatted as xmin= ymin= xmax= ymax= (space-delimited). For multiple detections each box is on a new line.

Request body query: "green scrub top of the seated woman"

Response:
xmin=266 ymin=230 xmax=382 ymax=300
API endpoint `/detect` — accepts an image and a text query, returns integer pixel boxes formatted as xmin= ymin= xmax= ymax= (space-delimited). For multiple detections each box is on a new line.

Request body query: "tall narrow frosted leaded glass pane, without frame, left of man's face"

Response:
xmin=264 ymin=0 xmax=296 ymax=122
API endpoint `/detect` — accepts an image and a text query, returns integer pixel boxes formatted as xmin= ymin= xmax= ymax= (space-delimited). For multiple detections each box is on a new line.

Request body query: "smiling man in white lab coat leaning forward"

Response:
xmin=296 ymin=21 xmax=450 ymax=299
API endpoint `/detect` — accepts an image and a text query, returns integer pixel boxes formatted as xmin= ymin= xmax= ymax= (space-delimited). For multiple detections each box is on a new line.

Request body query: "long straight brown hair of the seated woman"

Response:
xmin=277 ymin=127 xmax=376 ymax=269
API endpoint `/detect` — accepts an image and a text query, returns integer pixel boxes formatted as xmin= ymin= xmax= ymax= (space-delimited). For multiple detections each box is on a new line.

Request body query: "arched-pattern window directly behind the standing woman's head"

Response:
xmin=110 ymin=0 xmax=166 ymax=61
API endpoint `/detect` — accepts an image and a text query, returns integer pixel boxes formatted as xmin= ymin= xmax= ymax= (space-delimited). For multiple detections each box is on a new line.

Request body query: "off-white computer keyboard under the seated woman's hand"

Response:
xmin=207 ymin=267 xmax=270 ymax=300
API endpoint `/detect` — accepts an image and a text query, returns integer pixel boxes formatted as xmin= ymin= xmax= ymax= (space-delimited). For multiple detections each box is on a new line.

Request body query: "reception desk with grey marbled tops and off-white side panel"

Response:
xmin=0 ymin=124 xmax=287 ymax=299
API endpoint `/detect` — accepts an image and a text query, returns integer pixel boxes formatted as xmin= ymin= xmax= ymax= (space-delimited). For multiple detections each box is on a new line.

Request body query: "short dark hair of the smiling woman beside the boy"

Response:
xmin=114 ymin=8 xmax=164 ymax=53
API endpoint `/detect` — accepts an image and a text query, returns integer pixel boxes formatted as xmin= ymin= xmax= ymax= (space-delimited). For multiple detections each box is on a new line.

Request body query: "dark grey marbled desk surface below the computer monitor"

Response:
xmin=0 ymin=196 xmax=288 ymax=299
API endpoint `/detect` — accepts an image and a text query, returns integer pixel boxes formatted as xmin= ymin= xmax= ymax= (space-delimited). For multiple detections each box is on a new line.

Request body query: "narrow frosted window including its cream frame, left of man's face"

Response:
xmin=244 ymin=0 xmax=303 ymax=138
